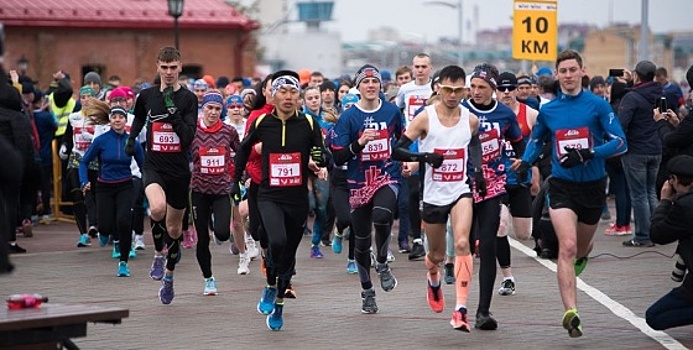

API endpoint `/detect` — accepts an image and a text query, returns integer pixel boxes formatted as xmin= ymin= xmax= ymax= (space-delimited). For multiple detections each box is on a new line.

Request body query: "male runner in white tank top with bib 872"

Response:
xmin=393 ymin=66 xmax=486 ymax=332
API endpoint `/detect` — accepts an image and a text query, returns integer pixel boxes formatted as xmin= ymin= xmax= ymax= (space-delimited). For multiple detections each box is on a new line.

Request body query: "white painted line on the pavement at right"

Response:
xmin=508 ymin=236 xmax=688 ymax=350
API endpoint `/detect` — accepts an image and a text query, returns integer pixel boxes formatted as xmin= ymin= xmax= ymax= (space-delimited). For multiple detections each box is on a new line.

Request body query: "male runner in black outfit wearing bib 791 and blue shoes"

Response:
xmin=231 ymin=71 xmax=325 ymax=330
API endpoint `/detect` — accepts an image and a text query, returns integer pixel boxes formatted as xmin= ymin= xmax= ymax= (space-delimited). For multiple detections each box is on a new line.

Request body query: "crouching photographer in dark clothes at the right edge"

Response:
xmin=645 ymin=155 xmax=693 ymax=330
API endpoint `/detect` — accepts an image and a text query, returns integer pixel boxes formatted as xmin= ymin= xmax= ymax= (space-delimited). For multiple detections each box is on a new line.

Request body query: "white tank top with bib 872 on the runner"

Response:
xmin=419 ymin=105 xmax=472 ymax=206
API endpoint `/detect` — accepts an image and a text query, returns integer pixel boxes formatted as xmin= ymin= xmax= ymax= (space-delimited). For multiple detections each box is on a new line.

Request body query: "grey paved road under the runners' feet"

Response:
xmin=0 ymin=219 xmax=693 ymax=349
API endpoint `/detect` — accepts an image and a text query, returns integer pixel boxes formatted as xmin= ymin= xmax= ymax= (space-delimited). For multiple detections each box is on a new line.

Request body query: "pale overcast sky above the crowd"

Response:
xmin=289 ymin=0 xmax=693 ymax=42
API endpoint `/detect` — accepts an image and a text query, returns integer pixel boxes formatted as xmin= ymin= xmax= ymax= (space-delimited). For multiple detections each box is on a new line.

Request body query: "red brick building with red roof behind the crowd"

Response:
xmin=0 ymin=0 xmax=259 ymax=88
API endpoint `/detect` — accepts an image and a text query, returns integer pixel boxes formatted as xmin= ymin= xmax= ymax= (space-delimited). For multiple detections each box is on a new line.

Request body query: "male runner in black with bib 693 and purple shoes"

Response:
xmin=125 ymin=47 xmax=197 ymax=304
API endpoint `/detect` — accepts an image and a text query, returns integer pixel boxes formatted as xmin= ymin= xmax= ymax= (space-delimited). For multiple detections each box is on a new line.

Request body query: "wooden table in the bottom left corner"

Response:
xmin=0 ymin=303 xmax=130 ymax=350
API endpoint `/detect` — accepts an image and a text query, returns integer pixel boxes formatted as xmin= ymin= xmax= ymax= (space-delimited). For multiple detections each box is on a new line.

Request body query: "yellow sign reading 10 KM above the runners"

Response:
xmin=513 ymin=0 xmax=558 ymax=61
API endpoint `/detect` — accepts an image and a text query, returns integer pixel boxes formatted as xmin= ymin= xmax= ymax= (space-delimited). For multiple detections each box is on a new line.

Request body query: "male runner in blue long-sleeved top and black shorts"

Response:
xmin=512 ymin=50 xmax=628 ymax=337
